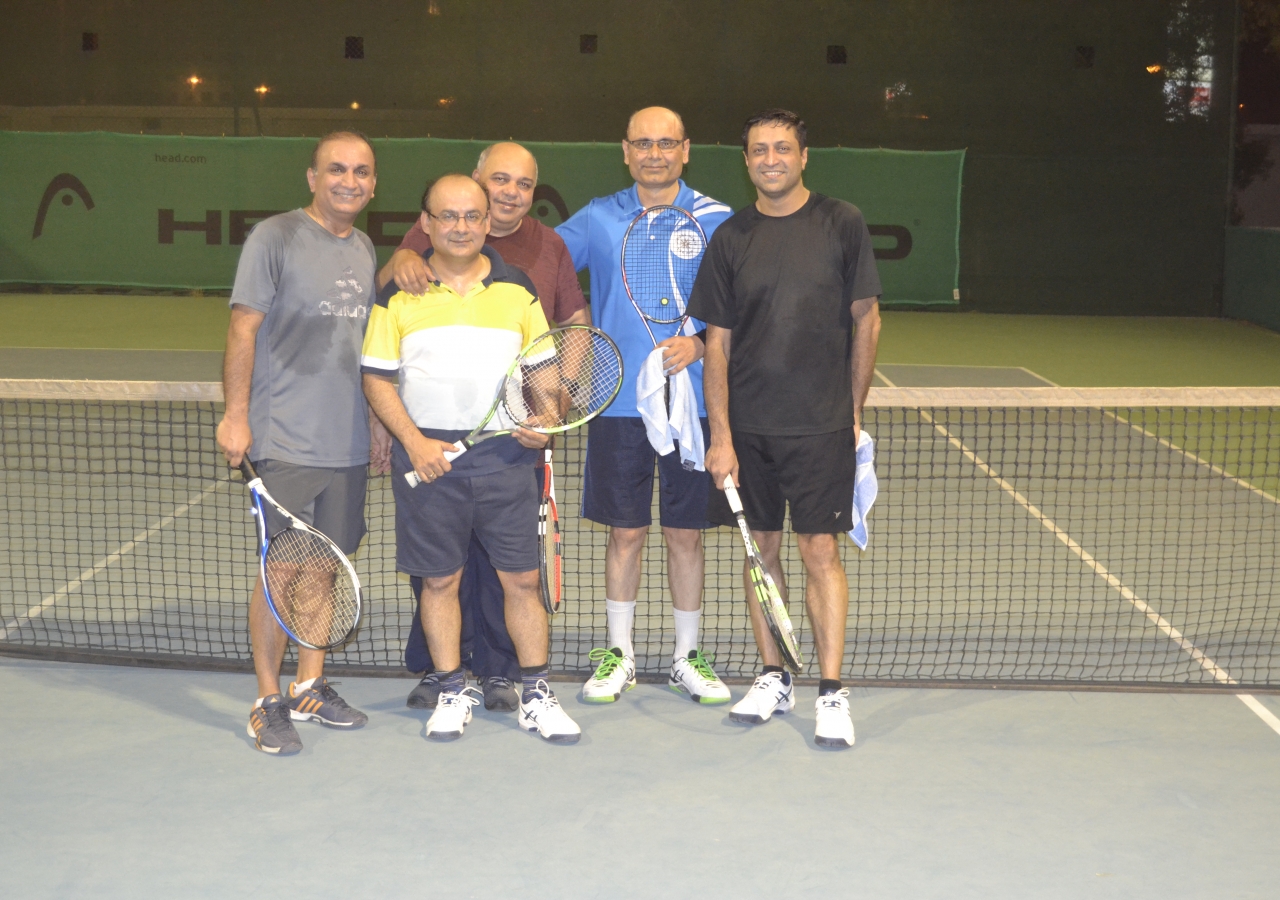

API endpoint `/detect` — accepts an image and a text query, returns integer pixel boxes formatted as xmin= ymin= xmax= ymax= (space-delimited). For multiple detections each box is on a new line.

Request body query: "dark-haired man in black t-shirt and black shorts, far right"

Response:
xmin=689 ymin=109 xmax=881 ymax=746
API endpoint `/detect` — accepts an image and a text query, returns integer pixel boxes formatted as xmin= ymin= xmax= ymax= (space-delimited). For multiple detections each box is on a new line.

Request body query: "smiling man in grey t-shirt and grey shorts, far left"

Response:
xmin=218 ymin=132 xmax=390 ymax=754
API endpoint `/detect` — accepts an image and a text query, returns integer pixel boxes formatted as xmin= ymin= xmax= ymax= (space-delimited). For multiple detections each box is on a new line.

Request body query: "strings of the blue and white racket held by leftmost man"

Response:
xmin=265 ymin=527 xmax=360 ymax=647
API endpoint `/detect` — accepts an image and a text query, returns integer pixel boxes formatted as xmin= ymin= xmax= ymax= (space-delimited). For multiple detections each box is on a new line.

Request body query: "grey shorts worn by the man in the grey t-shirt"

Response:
xmin=253 ymin=460 xmax=369 ymax=556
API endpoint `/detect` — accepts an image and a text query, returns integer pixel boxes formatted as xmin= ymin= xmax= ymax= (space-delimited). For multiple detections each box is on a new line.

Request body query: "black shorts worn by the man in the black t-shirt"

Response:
xmin=707 ymin=428 xmax=858 ymax=534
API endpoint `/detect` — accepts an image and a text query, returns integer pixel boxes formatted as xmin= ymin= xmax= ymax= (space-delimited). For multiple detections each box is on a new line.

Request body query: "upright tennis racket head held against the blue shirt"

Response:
xmin=622 ymin=206 xmax=707 ymax=347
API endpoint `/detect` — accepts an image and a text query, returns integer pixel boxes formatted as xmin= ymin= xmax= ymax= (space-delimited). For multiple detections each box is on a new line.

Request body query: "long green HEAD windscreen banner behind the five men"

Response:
xmin=0 ymin=132 xmax=964 ymax=305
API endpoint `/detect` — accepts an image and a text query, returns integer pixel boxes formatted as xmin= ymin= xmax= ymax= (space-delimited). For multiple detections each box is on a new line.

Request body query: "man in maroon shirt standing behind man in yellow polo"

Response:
xmin=378 ymin=142 xmax=590 ymax=712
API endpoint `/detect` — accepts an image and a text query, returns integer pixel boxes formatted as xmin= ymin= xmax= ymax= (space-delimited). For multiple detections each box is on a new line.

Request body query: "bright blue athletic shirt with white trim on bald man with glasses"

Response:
xmin=556 ymin=181 xmax=733 ymax=417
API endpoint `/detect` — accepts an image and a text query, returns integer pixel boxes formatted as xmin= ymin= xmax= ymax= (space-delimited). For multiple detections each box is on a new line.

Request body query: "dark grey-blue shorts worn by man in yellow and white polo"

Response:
xmin=392 ymin=457 xmax=538 ymax=579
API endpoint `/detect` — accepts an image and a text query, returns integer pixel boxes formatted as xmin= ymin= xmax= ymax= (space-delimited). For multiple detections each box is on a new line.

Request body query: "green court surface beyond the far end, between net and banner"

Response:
xmin=0 ymin=294 xmax=1280 ymax=387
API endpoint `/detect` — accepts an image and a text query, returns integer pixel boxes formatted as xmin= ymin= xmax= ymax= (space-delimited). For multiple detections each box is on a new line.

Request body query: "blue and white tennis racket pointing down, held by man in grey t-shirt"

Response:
xmin=239 ymin=458 xmax=361 ymax=650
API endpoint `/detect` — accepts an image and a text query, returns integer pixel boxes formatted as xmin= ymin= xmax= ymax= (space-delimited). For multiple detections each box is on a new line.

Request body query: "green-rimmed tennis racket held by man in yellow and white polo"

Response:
xmin=404 ymin=325 xmax=622 ymax=488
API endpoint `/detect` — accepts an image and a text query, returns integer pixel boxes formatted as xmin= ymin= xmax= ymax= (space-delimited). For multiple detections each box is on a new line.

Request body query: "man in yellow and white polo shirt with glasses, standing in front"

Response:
xmin=361 ymin=174 xmax=581 ymax=743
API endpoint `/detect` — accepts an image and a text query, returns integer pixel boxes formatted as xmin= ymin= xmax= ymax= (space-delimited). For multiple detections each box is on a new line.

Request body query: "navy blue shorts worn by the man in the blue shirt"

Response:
xmin=582 ymin=416 xmax=712 ymax=529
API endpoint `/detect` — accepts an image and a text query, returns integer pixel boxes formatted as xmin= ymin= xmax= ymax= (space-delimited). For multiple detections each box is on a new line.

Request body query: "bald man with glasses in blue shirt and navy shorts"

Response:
xmin=556 ymin=106 xmax=732 ymax=704
